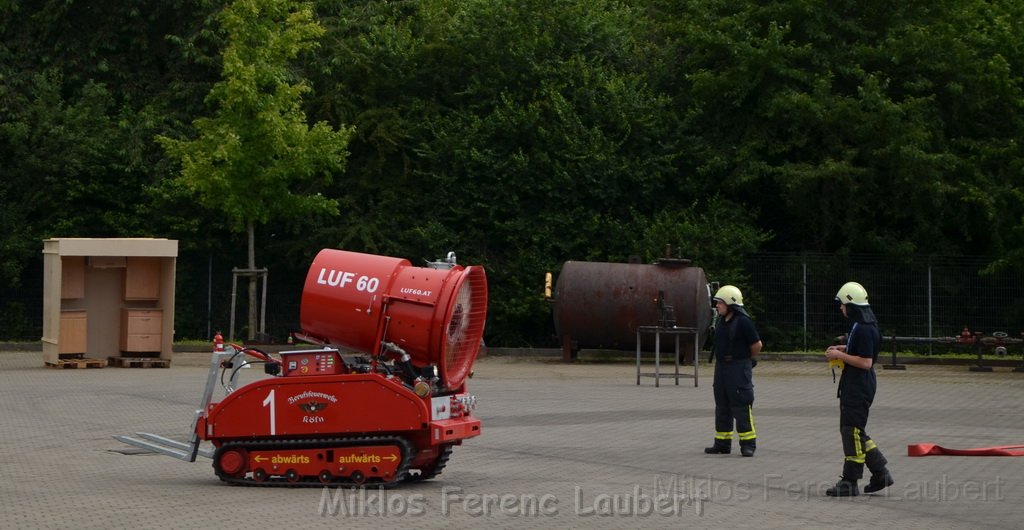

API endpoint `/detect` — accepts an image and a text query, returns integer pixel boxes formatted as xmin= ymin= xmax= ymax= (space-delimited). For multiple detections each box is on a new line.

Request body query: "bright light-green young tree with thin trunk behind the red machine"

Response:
xmin=158 ymin=0 xmax=352 ymax=340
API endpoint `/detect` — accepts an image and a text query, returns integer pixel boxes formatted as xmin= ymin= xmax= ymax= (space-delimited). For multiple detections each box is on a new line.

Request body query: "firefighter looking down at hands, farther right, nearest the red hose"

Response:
xmin=825 ymin=281 xmax=893 ymax=497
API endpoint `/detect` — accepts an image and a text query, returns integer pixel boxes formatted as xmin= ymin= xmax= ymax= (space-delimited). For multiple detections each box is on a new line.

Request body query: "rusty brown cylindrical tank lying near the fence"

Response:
xmin=554 ymin=259 xmax=713 ymax=360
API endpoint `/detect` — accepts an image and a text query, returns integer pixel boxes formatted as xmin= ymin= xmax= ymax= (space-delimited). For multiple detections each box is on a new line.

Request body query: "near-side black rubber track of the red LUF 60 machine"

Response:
xmin=213 ymin=436 xmax=413 ymax=488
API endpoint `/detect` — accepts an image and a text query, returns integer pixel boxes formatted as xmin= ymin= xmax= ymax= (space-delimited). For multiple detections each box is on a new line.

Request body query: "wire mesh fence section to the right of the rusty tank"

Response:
xmin=743 ymin=253 xmax=1024 ymax=351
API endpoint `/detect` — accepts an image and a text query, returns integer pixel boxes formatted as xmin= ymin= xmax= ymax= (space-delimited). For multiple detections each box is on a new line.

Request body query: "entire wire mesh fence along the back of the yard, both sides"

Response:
xmin=0 ymin=252 xmax=1024 ymax=351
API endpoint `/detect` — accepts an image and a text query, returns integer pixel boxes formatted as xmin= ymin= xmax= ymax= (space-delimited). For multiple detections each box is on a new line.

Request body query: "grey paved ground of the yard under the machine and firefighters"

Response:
xmin=0 ymin=352 xmax=1024 ymax=530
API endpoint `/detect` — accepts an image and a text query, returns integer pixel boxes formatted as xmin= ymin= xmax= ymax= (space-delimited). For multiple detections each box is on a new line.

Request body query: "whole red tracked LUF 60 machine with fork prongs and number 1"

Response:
xmin=115 ymin=249 xmax=487 ymax=486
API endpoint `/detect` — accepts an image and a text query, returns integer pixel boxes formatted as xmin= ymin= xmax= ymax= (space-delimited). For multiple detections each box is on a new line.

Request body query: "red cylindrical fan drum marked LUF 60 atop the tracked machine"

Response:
xmin=299 ymin=249 xmax=487 ymax=390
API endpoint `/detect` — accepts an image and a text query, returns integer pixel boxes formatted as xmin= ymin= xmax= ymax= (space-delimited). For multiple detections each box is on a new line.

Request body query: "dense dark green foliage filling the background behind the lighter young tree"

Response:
xmin=0 ymin=0 xmax=1024 ymax=346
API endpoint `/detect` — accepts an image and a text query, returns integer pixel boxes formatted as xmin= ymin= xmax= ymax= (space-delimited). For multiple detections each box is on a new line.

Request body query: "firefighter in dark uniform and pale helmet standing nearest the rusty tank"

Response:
xmin=705 ymin=285 xmax=762 ymax=456
